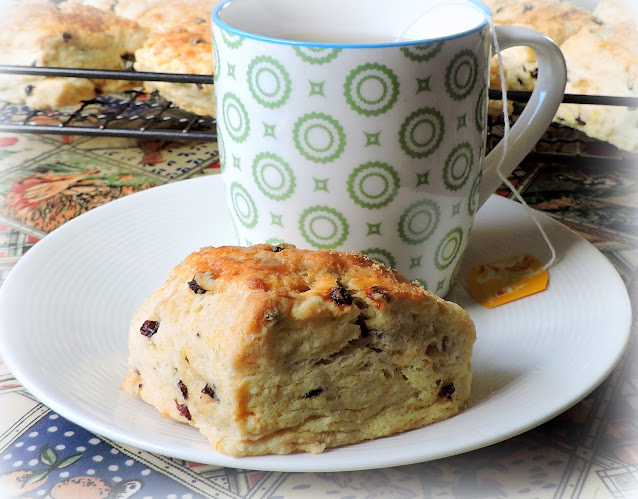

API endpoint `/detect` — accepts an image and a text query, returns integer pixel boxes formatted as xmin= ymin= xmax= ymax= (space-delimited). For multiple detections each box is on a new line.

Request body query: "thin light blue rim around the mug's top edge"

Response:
xmin=211 ymin=0 xmax=492 ymax=48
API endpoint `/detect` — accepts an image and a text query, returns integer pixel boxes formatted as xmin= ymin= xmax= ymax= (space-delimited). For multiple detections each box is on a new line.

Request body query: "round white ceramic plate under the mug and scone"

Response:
xmin=0 ymin=177 xmax=631 ymax=471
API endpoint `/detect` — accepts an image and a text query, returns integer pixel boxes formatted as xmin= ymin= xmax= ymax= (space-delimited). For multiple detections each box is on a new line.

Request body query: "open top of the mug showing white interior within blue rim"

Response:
xmin=213 ymin=0 xmax=491 ymax=46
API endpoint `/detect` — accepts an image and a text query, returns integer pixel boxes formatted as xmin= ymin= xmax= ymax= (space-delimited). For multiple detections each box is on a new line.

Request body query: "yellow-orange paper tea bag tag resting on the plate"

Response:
xmin=468 ymin=254 xmax=549 ymax=308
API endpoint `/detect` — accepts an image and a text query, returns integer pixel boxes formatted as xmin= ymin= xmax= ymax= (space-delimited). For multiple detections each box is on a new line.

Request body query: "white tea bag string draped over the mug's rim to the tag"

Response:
xmin=395 ymin=0 xmax=556 ymax=272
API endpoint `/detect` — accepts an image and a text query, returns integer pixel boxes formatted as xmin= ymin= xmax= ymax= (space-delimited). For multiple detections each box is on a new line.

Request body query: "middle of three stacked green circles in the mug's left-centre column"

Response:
xmin=292 ymin=113 xmax=346 ymax=163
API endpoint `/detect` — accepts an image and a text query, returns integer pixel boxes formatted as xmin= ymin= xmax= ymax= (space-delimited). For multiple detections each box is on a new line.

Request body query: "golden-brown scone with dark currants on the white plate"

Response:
xmin=123 ymin=244 xmax=476 ymax=456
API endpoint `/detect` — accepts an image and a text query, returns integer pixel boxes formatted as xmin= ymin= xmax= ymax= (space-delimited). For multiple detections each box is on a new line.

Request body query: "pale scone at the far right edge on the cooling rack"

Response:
xmin=555 ymin=23 xmax=638 ymax=152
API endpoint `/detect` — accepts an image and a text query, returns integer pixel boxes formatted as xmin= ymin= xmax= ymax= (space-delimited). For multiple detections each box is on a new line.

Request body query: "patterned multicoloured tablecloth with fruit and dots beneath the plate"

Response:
xmin=0 ymin=134 xmax=638 ymax=499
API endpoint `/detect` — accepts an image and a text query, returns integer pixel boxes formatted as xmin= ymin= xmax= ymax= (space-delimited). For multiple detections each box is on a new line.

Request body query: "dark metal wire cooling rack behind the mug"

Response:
xmin=0 ymin=65 xmax=638 ymax=162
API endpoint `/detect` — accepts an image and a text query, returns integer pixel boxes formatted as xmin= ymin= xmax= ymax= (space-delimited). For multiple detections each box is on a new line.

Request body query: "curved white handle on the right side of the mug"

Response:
xmin=478 ymin=26 xmax=567 ymax=207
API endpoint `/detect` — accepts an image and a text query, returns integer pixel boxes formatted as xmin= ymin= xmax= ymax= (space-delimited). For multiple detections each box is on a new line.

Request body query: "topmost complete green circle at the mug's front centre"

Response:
xmin=344 ymin=63 xmax=399 ymax=116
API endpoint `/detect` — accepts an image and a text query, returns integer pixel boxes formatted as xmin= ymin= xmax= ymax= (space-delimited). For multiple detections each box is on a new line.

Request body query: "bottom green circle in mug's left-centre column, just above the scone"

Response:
xmin=299 ymin=206 xmax=350 ymax=249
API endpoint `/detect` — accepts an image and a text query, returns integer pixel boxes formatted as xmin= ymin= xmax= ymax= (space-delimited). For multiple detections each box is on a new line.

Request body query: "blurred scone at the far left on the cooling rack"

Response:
xmin=0 ymin=0 xmax=146 ymax=108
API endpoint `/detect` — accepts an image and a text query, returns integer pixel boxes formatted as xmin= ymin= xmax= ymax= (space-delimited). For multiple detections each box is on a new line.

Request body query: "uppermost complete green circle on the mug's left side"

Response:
xmin=248 ymin=56 xmax=291 ymax=109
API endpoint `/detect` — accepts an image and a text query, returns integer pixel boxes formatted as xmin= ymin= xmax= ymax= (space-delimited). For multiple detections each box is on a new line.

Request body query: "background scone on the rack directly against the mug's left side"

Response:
xmin=135 ymin=0 xmax=219 ymax=116
